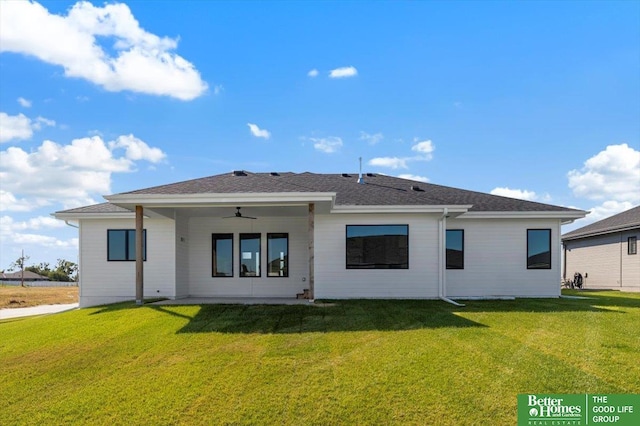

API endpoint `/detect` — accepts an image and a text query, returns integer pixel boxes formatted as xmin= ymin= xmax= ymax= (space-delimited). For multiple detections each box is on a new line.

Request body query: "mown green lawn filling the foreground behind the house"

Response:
xmin=0 ymin=291 xmax=640 ymax=425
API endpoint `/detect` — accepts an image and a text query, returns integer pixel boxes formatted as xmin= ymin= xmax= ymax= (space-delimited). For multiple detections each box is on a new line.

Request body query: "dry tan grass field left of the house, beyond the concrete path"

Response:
xmin=0 ymin=285 xmax=78 ymax=309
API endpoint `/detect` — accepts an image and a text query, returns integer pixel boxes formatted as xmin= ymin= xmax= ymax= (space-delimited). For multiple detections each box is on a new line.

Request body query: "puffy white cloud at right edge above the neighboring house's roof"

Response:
xmin=567 ymin=144 xmax=640 ymax=204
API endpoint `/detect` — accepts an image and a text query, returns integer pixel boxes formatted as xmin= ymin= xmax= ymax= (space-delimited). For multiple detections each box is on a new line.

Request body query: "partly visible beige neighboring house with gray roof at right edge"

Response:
xmin=562 ymin=206 xmax=640 ymax=291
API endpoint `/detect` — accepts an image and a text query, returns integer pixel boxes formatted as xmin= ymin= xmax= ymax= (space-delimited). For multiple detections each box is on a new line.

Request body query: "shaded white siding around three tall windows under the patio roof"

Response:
xmin=189 ymin=216 xmax=308 ymax=297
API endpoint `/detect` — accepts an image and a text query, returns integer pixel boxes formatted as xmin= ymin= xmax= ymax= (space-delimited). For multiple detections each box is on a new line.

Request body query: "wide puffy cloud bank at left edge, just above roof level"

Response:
xmin=0 ymin=135 xmax=166 ymax=211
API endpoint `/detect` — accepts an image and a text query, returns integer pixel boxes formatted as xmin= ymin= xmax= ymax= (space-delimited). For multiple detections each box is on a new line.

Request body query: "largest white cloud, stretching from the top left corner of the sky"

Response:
xmin=0 ymin=1 xmax=207 ymax=100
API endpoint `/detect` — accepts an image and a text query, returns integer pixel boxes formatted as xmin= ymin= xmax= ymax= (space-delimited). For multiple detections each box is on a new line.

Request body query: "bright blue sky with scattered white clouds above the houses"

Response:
xmin=0 ymin=1 xmax=640 ymax=269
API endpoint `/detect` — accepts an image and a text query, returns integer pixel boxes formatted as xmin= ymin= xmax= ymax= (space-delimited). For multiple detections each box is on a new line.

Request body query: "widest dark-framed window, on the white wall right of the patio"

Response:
xmin=347 ymin=225 xmax=409 ymax=269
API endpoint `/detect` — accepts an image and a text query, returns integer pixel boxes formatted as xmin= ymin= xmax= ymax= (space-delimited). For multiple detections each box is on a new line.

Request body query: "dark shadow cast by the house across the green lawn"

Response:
xmin=86 ymin=292 xmax=640 ymax=334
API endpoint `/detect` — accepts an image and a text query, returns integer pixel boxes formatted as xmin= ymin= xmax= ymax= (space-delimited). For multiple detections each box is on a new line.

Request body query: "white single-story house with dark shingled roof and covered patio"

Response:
xmin=55 ymin=171 xmax=586 ymax=306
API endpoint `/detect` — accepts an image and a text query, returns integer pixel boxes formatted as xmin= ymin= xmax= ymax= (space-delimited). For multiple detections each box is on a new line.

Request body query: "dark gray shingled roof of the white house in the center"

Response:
xmin=107 ymin=171 xmax=578 ymax=212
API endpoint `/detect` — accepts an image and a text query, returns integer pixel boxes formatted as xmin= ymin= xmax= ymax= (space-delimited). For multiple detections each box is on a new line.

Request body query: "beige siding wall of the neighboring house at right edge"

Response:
xmin=565 ymin=230 xmax=640 ymax=291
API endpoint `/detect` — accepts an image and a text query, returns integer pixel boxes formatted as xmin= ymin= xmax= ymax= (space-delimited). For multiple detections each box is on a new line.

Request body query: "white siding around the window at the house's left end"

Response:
xmin=80 ymin=219 xmax=175 ymax=307
